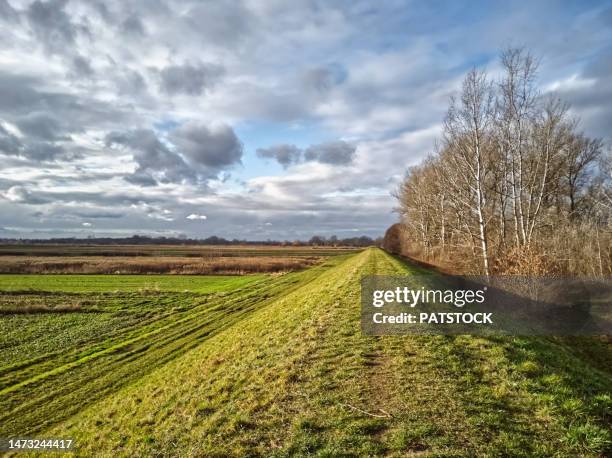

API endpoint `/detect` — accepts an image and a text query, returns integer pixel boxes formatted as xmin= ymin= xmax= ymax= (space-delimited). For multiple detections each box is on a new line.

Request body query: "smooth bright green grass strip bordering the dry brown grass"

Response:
xmin=0 ymin=274 xmax=263 ymax=293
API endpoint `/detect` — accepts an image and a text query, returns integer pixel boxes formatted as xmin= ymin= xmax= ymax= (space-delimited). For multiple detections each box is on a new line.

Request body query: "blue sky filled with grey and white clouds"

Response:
xmin=0 ymin=0 xmax=612 ymax=240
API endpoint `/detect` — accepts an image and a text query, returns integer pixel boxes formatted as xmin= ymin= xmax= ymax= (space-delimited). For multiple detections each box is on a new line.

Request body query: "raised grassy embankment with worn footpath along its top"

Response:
xmin=32 ymin=249 xmax=612 ymax=456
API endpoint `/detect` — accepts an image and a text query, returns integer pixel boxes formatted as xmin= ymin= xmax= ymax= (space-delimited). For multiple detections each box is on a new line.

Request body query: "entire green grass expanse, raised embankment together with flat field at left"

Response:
xmin=0 ymin=248 xmax=612 ymax=456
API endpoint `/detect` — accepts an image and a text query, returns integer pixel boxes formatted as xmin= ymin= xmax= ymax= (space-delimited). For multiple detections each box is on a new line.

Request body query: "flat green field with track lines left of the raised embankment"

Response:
xmin=0 ymin=257 xmax=350 ymax=434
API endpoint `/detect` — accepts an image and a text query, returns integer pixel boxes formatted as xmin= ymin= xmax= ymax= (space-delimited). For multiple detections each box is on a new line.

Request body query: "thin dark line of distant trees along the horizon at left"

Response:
xmin=0 ymin=235 xmax=382 ymax=247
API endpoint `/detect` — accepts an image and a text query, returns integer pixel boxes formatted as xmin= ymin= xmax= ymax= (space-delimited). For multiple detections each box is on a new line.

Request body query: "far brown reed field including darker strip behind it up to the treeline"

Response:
xmin=0 ymin=245 xmax=354 ymax=275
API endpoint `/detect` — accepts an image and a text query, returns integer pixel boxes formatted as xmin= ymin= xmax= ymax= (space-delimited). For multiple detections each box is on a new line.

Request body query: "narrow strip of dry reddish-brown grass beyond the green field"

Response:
xmin=0 ymin=256 xmax=320 ymax=275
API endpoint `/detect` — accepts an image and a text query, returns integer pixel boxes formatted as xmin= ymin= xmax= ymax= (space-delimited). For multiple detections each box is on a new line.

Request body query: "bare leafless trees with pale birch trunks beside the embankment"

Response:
xmin=396 ymin=49 xmax=612 ymax=275
